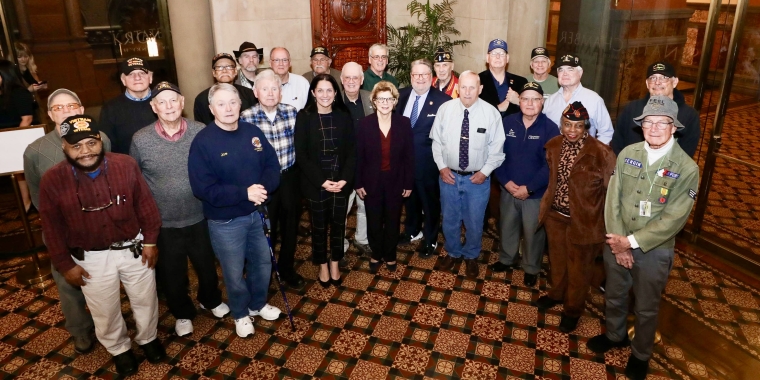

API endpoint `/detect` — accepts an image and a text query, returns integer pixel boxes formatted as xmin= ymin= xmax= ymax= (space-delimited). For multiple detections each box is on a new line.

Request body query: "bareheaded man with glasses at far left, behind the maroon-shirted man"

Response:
xmin=24 ymin=88 xmax=111 ymax=353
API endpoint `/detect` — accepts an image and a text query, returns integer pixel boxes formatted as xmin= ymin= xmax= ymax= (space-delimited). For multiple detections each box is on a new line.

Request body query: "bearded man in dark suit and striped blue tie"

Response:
xmin=396 ymin=59 xmax=451 ymax=258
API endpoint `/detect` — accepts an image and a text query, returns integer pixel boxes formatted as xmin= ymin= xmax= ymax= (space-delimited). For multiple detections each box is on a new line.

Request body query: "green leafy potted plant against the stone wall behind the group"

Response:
xmin=387 ymin=0 xmax=470 ymax=86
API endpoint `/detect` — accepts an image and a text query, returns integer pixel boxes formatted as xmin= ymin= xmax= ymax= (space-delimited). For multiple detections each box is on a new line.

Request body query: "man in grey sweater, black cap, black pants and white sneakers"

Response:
xmin=129 ymin=82 xmax=230 ymax=336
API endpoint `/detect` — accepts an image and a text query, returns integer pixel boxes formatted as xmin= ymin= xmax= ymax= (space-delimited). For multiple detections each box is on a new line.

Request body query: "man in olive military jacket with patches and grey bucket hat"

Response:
xmin=586 ymin=95 xmax=699 ymax=380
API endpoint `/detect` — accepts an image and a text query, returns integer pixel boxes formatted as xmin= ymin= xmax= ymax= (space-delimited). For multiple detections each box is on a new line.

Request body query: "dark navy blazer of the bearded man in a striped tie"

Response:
xmin=396 ymin=87 xmax=451 ymax=184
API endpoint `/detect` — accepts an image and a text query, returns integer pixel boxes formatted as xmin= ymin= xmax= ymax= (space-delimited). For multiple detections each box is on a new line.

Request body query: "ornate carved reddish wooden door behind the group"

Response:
xmin=311 ymin=0 xmax=386 ymax=70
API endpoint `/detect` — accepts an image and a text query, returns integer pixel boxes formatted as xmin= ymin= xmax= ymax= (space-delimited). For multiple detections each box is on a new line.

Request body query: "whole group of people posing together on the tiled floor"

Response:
xmin=24 ymin=39 xmax=699 ymax=379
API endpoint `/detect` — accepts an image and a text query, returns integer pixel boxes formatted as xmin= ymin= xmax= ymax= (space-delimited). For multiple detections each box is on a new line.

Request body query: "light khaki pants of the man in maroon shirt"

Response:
xmin=74 ymin=249 xmax=158 ymax=356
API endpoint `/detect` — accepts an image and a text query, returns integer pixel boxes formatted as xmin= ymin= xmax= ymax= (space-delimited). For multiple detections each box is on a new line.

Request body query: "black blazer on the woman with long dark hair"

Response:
xmin=295 ymin=109 xmax=356 ymax=199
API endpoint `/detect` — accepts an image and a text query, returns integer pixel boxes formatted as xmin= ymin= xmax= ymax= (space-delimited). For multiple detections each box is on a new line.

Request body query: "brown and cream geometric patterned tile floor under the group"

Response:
xmin=0 ymin=218 xmax=760 ymax=380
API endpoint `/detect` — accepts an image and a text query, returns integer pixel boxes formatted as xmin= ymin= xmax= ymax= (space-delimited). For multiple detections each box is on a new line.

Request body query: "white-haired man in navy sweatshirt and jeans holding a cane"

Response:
xmin=188 ymin=83 xmax=280 ymax=338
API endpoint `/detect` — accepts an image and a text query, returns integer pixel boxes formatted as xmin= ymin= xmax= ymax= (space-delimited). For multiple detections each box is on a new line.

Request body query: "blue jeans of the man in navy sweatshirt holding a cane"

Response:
xmin=208 ymin=211 xmax=272 ymax=319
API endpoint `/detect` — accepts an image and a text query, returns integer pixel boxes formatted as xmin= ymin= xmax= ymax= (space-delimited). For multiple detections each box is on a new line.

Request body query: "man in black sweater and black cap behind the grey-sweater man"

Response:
xmin=99 ymin=57 xmax=156 ymax=154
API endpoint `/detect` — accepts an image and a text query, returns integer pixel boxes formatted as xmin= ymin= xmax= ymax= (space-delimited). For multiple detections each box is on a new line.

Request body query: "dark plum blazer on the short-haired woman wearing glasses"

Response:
xmin=354 ymin=113 xmax=414 ymax=197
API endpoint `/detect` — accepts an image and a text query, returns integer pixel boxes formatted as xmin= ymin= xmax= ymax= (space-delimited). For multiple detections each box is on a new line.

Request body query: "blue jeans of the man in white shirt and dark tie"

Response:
xmin=438 ymin=172 xmax=491 ymax=259
